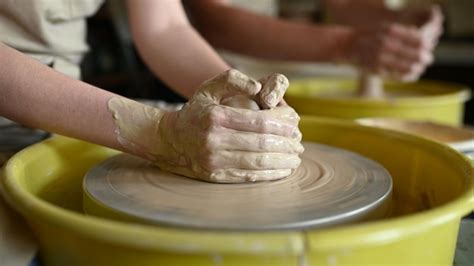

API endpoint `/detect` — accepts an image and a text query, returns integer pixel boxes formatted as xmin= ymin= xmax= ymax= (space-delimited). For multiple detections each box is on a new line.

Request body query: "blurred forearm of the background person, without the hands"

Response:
xmin=189 ymin=1 xmax=351 ymax=61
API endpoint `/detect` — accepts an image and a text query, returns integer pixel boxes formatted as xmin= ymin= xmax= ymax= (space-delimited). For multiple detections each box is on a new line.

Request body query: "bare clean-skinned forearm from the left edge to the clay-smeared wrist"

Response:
xmin=0 ymin=44 xmax=123 ymax=150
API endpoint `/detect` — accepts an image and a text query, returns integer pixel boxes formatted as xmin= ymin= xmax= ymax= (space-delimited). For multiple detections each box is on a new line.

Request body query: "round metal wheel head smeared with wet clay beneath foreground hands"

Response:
xmin=84 ymin=143 xmax=392 ymax=230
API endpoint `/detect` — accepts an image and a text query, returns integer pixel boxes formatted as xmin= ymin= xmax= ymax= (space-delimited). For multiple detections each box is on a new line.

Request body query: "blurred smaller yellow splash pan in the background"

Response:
xmin=285 ymin=78 xmax=470 ymax=125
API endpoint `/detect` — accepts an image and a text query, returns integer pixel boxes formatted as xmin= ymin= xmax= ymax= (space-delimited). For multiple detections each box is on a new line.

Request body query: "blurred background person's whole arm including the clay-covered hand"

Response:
xmin=188 ymin=0 xmax=442 ymax=81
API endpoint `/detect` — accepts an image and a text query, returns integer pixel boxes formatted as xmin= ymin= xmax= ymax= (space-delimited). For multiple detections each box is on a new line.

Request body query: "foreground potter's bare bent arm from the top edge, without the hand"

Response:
xmin=127 ymin=0 xmax=229 ymax=98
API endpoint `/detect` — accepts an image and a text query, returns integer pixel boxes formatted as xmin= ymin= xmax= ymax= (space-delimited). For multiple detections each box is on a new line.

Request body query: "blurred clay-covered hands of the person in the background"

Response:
xmin=343 ymin=6 xmax=443 ymax=81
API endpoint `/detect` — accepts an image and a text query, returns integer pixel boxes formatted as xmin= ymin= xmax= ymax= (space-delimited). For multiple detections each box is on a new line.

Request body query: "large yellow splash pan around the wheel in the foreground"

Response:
xmin=3 ymin=117 xmax=474 ymax=266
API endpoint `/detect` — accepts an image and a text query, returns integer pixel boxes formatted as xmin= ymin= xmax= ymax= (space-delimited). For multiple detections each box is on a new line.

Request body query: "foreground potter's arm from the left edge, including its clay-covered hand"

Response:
xmin=0 ymin=44 xmax=303 ymax=183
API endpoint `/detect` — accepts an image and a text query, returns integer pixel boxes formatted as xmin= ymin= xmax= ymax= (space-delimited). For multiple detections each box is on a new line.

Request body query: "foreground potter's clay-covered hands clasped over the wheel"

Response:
xmin=139 ymin=70 xmax=303 ymax=183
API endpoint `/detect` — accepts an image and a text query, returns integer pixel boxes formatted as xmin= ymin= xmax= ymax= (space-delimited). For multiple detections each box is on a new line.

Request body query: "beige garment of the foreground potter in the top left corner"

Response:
xmin=0 ymin=0 xmax=104 ymax=79
